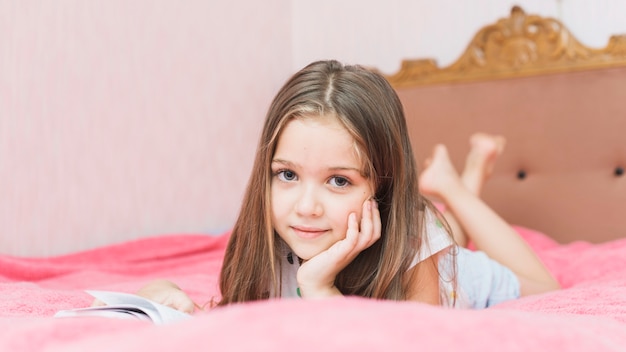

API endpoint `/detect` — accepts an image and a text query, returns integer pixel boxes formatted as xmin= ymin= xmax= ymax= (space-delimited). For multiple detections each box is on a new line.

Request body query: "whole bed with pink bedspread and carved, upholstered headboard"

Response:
xmin=0 ymin=7 xmax=626 ymax=351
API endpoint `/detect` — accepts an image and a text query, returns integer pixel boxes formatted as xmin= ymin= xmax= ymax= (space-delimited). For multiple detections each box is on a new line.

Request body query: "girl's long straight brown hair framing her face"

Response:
xmin=219 ymin=60 xmax=444 ymax=305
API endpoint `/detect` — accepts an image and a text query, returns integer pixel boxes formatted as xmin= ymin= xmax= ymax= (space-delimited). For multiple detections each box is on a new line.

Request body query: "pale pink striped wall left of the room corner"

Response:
xmin=0 ymin=0 xmax=291 ymax=256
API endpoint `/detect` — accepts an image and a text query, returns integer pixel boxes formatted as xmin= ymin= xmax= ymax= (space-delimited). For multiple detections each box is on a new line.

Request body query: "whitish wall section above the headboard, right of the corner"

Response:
xmin=293 ymin=0 xmax=626 ymax=73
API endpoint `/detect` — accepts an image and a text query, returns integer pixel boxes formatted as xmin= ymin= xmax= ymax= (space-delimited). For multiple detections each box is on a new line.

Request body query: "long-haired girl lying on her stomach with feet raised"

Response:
xmin=139 ymin=61 xmax=558 ymax=311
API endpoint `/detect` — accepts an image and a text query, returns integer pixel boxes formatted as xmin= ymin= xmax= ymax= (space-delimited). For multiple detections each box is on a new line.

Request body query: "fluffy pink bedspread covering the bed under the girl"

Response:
xmin=0 ymin=228 xmax=626 ymax=352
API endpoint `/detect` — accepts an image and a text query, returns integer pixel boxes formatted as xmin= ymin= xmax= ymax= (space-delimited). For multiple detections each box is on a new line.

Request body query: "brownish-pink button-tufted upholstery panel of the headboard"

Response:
xmin=396 ymin=66 xmax=626 ymax=243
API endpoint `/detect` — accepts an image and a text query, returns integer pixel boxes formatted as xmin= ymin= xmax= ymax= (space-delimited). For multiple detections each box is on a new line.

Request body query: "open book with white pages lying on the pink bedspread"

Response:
xmin=54 ymin=291 xmax=191 ymax=324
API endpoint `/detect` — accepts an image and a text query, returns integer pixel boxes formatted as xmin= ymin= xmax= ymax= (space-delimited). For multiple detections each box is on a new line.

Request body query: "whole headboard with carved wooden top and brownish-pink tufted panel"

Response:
xmin=380 ymin=6 xmax=626 ymax=243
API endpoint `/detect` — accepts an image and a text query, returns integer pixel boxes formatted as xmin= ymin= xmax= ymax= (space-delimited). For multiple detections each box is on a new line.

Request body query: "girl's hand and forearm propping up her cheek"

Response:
xmin=297 ymin=200 xmax=381 ymax=298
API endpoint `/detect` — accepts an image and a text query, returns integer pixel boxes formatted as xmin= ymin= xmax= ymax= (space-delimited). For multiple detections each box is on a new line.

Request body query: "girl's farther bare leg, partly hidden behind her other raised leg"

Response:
xmin=420 ymin=133 xmax=506 ymax=247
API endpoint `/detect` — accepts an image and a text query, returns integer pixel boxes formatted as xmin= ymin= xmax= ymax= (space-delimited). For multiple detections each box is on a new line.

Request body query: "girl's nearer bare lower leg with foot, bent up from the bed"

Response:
xmin=420 ymin=145 xmax=559 ymax=295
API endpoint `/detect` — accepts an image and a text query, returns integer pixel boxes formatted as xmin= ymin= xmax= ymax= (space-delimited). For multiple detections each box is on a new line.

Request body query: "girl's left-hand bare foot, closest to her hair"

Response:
xmin=419 ymin=144 xmax=464 ymax=199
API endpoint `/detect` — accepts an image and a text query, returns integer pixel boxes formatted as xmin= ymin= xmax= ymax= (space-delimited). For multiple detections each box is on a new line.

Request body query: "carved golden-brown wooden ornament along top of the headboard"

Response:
xmin=386 ymin=6 xmax=626 ymax=88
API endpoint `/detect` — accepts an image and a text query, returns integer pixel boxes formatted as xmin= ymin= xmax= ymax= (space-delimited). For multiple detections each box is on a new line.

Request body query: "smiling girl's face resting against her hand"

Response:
xmin=271 ymin=115 xmax=373 ymax=260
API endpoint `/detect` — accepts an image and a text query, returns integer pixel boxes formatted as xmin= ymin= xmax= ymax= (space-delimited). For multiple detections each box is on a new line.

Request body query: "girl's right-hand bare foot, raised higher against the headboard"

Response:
xmin=461 ymin=133 xmax=506 ymax=195
